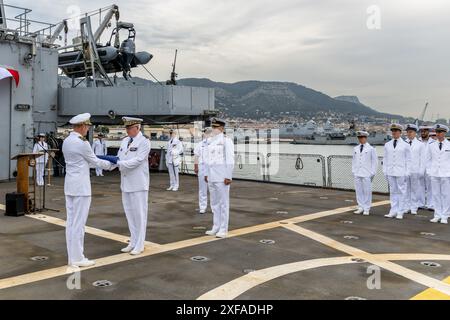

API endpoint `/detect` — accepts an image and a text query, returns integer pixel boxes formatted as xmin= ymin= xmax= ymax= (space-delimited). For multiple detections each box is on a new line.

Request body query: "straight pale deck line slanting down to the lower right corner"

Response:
xmin=282 ymin=225 xmax=450 ymax=295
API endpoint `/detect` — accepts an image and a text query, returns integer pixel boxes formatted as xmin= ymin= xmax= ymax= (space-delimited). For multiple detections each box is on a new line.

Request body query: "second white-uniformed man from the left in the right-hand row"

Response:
xmin=383 ymin=124 xmax=411 ymax=220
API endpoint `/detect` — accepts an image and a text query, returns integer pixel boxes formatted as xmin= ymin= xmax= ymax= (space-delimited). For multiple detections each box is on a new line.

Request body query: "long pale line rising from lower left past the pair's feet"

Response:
xmin=0 ymin=201 xmax=389 ymax=290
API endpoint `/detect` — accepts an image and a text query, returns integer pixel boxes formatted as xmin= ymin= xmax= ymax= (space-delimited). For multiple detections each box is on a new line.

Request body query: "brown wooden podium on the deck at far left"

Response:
xmin=11 ymin=153 xmax=44 ymax=213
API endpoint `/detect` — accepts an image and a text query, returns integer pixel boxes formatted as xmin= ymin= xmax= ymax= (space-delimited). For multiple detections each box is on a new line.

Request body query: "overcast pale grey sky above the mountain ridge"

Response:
xmin=5 ymin=0 xmax=450 ymax=119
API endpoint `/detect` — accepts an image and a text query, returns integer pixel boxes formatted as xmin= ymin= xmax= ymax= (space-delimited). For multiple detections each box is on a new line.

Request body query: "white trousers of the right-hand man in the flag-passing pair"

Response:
xmin=122 ymin=191 xmax=148 ymax=251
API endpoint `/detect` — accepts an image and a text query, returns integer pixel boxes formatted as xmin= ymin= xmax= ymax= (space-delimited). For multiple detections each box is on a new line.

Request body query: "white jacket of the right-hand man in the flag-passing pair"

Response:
xmin=117 ymin=132 xmax=151 ymax=192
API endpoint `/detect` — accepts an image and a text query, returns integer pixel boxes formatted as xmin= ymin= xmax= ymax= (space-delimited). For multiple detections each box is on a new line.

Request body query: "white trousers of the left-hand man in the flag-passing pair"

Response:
xmin=66 ymin=196 xmax=91 ymax=265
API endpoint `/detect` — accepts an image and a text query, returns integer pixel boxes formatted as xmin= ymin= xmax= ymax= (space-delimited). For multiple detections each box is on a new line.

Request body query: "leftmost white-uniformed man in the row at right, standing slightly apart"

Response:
xmin=352 ymin=131 xmax=378 ymax=216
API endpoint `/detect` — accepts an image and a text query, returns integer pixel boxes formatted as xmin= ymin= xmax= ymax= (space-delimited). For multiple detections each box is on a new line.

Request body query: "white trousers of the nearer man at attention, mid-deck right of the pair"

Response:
xmin=208 ymin=182 xmax=230 ymax=233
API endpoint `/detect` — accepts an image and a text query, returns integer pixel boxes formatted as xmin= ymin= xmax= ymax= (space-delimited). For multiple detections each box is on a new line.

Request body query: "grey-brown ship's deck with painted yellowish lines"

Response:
xmin=0 ymin=173 xmax=450 ymax=299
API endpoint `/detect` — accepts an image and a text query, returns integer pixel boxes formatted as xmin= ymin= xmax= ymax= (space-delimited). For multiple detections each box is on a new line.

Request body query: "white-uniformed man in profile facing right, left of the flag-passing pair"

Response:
xmin=62 ymin=113 xmax=114 ymax=267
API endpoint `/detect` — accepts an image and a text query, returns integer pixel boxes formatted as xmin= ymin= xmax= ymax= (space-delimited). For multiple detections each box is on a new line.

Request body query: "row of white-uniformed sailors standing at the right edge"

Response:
xmin=352 ymin=124 xmax=450 ymax=224
